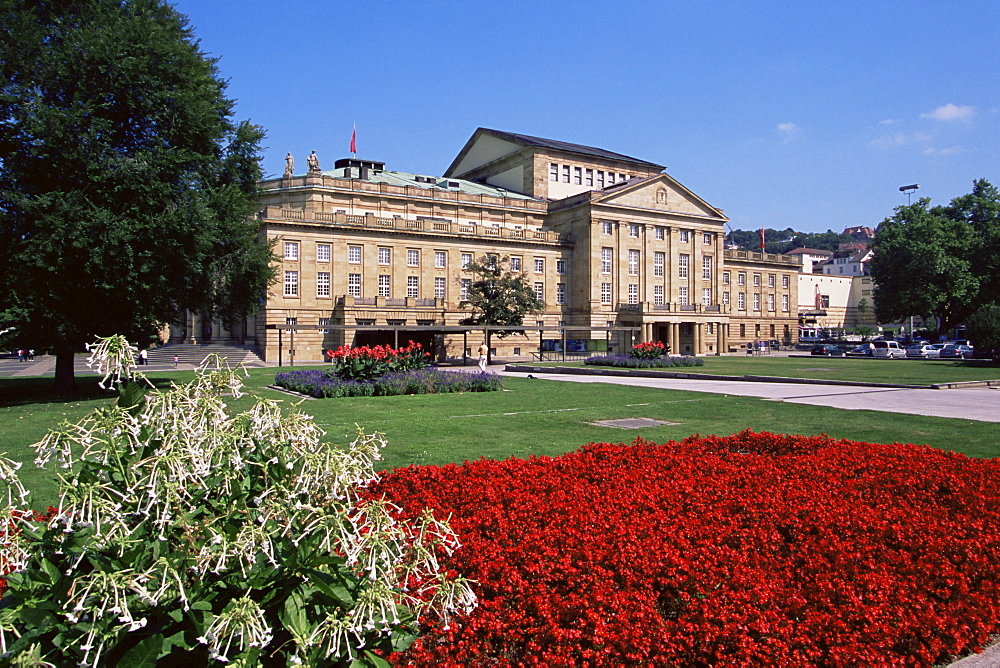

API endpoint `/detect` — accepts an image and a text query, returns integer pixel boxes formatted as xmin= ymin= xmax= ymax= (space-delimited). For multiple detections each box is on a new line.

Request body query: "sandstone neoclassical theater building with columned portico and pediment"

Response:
xmin=172 ymin=128 xmax=801 ymax=362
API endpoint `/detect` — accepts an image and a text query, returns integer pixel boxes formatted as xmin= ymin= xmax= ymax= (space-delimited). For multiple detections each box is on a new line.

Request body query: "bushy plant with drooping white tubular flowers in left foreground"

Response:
xmin=0 ymin=350 xmax=476 ymax=666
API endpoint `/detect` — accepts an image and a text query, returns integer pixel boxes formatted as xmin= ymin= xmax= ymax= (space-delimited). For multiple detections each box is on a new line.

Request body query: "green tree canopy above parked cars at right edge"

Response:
xmin=870 ymin=179 xmax=1000 ymax=333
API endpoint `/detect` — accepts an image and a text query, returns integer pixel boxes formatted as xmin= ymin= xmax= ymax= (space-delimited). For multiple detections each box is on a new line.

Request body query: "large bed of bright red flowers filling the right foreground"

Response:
xmin=372 ymin=432 xmax=1000 ymax=666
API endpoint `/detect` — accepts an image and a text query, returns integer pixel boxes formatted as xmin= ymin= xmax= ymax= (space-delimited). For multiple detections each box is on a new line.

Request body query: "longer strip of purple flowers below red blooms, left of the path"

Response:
xmin=274 ymin=367 xmax=503 ymax=398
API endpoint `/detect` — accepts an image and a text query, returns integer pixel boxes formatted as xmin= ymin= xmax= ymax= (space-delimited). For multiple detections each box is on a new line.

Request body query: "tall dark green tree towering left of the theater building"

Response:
xmin=0 ymin=0 xmax=274 ymax=390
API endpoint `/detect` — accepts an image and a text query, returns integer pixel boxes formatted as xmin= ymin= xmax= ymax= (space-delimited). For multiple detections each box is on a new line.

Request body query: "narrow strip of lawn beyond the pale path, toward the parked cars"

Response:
xmin=535 ymin=356 xmax=1000 ymax=385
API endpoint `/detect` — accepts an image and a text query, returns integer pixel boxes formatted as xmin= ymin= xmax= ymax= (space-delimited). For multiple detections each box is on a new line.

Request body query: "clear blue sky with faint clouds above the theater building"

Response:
xmin=174 ymin=0 xmax=1000 ymax=232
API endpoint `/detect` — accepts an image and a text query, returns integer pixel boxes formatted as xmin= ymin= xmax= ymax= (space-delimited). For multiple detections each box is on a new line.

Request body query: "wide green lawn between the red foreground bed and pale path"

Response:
xmin=0 ymin=368 xmax=1000 ymax=506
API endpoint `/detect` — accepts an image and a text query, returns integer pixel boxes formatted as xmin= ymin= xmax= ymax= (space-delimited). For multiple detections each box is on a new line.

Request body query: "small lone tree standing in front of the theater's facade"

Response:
xmin=462 ymin=255 xmax=545 ymax=360
